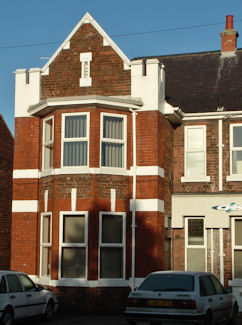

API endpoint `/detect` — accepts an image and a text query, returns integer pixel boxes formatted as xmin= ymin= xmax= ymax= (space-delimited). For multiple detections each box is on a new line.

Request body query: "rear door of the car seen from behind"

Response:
xmin=199 ymin=275 xmax=221 ymax=323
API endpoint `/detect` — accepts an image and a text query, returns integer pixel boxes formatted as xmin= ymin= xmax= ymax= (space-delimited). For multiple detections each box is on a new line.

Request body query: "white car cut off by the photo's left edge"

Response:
xmin=0 ymin=271 xmax=58 ymax=325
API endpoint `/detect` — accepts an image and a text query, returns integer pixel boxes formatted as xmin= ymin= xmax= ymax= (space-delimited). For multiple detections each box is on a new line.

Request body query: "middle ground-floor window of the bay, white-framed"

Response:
xmin=60 ymin=212 xmax=88 ymax=279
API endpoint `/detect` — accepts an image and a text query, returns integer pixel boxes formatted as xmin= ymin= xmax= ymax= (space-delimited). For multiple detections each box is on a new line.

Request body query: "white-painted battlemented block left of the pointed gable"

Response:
xmin=15 ymin=68 xmax=40 ymax=117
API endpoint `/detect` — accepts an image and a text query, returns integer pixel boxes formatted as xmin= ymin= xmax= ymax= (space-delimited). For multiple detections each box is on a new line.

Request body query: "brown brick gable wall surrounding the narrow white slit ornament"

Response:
xmin=41 ymin=24 xmax=130 ymax=99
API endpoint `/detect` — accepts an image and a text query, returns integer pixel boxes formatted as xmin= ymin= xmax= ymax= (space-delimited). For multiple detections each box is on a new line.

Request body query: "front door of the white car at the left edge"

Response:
xmin=18 ymin=273 xmax=44 ymax=316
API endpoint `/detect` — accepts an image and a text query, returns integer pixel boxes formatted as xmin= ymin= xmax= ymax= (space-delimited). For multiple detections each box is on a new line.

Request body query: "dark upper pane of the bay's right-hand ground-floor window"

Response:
xmin=102 ymin=215 xmax=123 ymax=243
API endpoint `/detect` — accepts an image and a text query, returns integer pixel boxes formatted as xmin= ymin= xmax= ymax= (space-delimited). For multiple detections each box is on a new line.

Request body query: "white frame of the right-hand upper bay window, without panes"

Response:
xmin=100 ymin=113 xmax=127 ymax=171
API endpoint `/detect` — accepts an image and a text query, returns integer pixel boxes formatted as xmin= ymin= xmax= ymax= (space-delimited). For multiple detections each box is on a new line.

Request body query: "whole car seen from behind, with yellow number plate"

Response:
xmin=125 ymin=271 xmax=238 ymax=325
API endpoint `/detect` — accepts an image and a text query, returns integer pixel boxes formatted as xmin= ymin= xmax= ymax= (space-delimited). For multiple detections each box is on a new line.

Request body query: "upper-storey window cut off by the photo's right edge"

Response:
xmin=230 ymin=124 xmax=242 ymax=175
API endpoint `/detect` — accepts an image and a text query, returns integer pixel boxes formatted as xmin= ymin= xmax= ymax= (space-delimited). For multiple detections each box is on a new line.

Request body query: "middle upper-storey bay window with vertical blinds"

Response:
xmin=62 ymin=113 xmax=89 ymax=167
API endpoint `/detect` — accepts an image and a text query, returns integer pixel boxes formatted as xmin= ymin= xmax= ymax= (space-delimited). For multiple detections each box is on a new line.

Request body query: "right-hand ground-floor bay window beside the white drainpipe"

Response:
xmin=99 ymin=212 xmax=125 ymax=279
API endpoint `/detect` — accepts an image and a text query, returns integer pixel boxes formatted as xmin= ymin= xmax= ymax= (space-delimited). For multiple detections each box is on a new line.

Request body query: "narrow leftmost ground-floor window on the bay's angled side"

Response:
xmin=40 ymin=213 xmax=52 ymax=277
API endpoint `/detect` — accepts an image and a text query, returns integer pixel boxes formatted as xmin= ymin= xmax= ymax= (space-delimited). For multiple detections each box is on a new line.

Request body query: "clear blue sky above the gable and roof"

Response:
xmin=0 ymin=0 xmax=242 ymax=134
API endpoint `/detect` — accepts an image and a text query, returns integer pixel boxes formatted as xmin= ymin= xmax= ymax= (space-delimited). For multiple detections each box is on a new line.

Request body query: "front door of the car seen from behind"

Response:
xmin=211 ymin=275 xmax=233 ymax=320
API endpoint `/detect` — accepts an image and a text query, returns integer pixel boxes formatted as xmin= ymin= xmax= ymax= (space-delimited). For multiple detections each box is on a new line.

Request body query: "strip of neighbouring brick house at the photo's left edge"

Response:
xmin=0 ymin=114 xmax=13 ymax=270
